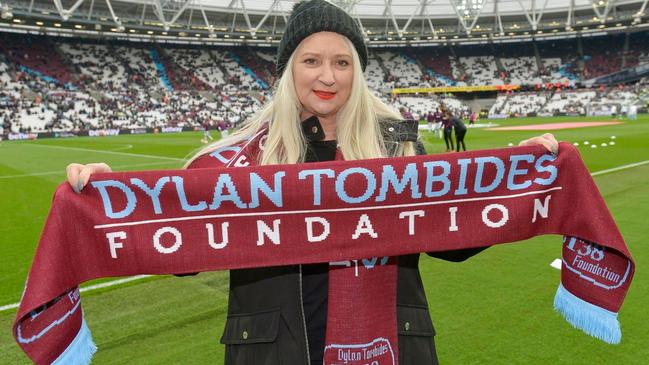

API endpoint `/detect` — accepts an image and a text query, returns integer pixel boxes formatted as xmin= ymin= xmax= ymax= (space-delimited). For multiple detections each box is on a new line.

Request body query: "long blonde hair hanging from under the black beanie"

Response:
xmin=185 ymin=38 xmax=415 ymax=167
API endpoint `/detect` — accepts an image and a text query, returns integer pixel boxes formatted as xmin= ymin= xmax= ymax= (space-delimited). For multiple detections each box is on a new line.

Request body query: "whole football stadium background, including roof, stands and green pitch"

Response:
xmin=0 ymin=0 xmax=649 ymax=364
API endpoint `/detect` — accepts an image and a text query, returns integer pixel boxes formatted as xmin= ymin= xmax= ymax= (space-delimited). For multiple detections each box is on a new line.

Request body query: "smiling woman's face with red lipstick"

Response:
xmin=292 ymin=32 xmax=354 ymax=119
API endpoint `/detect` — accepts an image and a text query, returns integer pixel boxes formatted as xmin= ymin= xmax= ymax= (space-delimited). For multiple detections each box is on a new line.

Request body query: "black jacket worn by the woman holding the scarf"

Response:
xmin=221 ymin=122 xmax=480 ymax=365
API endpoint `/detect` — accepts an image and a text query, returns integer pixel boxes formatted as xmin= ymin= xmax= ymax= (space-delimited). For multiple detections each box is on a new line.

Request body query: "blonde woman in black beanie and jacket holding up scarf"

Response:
xmin=67 ymin=0 xmax=557 ymax=365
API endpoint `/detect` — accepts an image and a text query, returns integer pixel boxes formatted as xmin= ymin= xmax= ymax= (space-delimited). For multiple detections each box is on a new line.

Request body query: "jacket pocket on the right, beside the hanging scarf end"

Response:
xmin=397 ymin=304 xmax=439 ymax=365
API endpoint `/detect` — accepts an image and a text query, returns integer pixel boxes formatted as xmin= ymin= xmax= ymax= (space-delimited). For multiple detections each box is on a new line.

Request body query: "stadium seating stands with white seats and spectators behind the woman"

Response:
xmin=0 ymin=32 xmax=649 ymax=132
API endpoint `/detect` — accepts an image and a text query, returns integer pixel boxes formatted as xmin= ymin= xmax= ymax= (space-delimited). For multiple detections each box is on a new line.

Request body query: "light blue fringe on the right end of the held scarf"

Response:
xmin=554 ymin=284 xmax=622 ymax=344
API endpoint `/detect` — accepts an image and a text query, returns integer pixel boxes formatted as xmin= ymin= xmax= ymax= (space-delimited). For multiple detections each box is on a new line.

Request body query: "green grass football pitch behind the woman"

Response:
xmin=0 ymin=115 xmax=649 ymax=365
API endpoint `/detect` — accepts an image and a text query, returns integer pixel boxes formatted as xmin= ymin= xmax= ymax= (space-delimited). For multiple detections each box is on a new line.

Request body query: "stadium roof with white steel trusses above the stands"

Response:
xmin=0 ymin=0 xmax=649 ymax=44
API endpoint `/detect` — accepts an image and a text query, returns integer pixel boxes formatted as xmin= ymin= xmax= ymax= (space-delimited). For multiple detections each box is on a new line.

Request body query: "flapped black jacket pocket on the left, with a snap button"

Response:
xmin=221 ymin=308 xmax=280 ymax=365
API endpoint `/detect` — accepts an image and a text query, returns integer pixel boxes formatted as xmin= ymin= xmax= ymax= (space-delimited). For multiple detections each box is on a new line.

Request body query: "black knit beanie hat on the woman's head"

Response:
xmin=275 ymin=0 xmax=367 ymax=78
